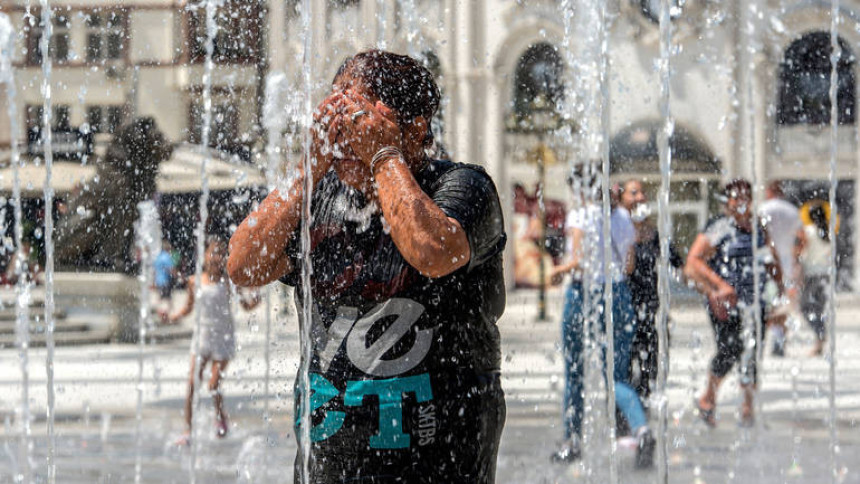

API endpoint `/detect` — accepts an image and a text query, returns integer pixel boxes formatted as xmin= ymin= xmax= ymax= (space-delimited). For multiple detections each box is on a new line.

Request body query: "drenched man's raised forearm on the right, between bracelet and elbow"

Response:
xmin=374 ymin=157 xmax=470 ymax=277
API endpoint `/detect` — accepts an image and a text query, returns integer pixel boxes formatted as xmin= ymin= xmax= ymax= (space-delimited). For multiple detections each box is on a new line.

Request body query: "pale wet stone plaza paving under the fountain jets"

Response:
xmin=0 ymin=290 xmax=860 ymax=484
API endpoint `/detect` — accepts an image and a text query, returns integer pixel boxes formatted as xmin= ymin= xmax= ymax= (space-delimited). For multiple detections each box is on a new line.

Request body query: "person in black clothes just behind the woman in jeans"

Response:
xmin=619 ymin=180 xmax=684 ymax=402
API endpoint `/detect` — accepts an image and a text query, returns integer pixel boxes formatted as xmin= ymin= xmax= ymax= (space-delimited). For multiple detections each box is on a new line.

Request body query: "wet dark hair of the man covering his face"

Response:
xmin=334 ymin=49 xmax=442 ymax=140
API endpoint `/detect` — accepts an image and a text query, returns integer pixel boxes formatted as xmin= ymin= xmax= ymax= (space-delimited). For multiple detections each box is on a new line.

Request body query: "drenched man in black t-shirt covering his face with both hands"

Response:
xmin=229 ymin=50 xmax=505 ymax=484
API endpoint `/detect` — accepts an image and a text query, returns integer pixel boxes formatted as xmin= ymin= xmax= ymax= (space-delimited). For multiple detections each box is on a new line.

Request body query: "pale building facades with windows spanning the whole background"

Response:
xmin=0 ymin=0 xmax=860 ymax=290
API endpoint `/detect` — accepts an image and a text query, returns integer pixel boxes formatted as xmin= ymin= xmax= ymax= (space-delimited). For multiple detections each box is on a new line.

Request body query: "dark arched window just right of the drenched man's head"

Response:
xmin=513 ymin=43 xmax=564 ymax=119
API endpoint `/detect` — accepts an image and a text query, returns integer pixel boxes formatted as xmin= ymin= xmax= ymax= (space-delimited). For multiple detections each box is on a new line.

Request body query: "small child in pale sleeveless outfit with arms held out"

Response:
xmin=162 ymin=239 xmax=260 ymax=445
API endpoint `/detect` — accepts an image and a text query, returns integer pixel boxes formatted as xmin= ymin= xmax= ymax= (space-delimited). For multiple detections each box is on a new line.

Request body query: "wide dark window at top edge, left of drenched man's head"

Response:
xmin=188 ymin=0 xmax=264 ymax=64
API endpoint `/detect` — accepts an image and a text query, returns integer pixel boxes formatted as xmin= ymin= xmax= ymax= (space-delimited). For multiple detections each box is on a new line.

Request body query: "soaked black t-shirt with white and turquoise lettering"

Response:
xmin=283 ymin=161 xmax=505 ymax=484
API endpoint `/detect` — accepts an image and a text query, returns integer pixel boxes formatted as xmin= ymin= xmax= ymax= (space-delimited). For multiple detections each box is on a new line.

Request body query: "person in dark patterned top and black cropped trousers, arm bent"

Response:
xmin=684 ymin=179 xmax=782 ymax=427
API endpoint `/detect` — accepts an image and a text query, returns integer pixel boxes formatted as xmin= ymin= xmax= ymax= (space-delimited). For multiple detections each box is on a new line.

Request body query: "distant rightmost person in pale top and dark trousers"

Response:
xmin=795 ymin=200 xmax=833 ymax=356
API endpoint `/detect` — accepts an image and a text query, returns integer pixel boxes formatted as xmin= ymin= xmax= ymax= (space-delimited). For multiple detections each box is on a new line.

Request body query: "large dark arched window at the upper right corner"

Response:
xmin=777 ymin=32 xmax=856 ymax=125
